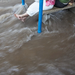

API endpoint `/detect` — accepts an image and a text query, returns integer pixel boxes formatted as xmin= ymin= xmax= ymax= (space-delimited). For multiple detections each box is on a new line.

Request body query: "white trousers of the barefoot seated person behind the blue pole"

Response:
xmin=26 ymin=0 xmax=55 ymax=16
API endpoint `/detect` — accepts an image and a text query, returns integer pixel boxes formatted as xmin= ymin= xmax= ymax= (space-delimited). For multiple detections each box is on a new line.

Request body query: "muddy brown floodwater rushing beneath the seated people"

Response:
xmin=0 ymin=0 xmax=75 ymax=75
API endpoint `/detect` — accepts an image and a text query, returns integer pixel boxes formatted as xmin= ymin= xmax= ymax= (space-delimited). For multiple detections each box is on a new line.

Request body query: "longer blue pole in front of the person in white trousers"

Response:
xmin=38 ymin=0 xmax=43 ymax=33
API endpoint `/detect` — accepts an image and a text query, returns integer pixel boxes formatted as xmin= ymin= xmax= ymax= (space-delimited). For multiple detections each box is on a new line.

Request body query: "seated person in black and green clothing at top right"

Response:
xmin=54 ymin=0 xmax=74 ymax=8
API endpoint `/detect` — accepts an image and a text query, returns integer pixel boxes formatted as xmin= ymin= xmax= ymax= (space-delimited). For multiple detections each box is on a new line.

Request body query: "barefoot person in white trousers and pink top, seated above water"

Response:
xmin=14 ymin=0 xmax=55 ymax=22
